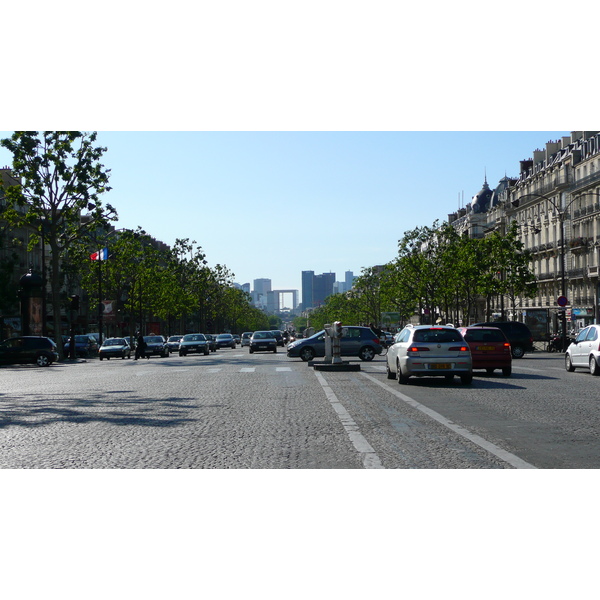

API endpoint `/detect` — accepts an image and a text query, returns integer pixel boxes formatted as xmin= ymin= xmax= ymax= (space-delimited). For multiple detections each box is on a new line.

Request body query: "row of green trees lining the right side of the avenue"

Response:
xmin=298 ymin=221 xmax=536 ymax=329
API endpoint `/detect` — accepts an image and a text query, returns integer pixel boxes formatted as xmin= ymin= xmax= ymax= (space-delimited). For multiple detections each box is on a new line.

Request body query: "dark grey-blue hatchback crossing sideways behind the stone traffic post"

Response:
xmin=287 ymin=325 xmax=383 ymax=361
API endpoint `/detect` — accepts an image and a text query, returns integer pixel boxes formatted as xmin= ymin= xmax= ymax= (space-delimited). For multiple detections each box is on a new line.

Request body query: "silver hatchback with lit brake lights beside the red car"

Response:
xmin=386 ymin=325 xmax=473 ymax=384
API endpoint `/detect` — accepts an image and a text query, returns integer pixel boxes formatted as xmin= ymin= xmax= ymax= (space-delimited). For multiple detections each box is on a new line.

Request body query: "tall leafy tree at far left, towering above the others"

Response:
xmin=0 ymin=131 xmax=117 ymax=356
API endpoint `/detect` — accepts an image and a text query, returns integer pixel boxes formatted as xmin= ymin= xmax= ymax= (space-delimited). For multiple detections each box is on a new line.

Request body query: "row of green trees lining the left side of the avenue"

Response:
xmin=0 ymin=131 xmax=269 ymax=356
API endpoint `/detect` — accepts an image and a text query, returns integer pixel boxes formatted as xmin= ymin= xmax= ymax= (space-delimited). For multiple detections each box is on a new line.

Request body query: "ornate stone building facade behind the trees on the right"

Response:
xmin=448 ymin=131 xmax=600 ymax=333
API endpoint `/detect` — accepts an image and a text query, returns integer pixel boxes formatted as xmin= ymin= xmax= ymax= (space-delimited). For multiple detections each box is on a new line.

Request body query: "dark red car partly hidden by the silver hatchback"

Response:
xmin=457 ymin=327 xmax=512 ymax=377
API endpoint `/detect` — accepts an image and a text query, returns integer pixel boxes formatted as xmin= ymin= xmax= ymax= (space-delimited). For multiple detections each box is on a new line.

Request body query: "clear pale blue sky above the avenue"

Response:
xmin=0 ymin=131 xmax=569 ymax=290
